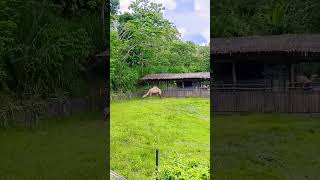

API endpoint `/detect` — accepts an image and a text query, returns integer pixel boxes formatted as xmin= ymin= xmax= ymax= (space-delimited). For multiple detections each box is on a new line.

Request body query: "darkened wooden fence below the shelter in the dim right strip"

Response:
xmin=210 ymin=91 xmax=320 ymax=113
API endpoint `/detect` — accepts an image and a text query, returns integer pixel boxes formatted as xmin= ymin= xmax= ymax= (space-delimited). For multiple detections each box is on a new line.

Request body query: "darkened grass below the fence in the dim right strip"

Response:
xmin=212 ymin=114 xmax=320 ymax=180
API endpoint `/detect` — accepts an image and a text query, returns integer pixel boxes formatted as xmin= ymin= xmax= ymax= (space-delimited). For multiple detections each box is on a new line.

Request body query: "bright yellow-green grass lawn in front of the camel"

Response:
xmin=110 ymin=97 xmax=210 ymax=180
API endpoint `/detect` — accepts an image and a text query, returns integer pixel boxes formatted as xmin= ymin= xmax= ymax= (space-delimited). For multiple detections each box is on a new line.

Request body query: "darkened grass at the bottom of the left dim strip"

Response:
xmin=0 ymin=112 xmax=107 ymax=180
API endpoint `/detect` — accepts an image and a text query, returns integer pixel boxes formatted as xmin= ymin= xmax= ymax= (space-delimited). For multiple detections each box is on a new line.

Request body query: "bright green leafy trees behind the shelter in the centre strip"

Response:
xmin=110 ymin=0 xmax=209 ymax=91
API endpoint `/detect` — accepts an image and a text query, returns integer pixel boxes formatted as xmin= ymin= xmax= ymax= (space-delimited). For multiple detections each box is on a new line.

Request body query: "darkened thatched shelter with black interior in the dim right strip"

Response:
xmin=211 ymin=34 xmax=320 ymax=90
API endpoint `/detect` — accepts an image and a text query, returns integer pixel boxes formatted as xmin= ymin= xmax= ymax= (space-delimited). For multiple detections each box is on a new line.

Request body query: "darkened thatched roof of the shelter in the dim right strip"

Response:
xmin=211 ymin=34 xmax=320 ymax=55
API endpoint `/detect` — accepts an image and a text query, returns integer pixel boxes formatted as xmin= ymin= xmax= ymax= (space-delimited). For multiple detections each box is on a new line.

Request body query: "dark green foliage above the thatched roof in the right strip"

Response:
xmin=211 ymin=0 xmax=320 ymax=37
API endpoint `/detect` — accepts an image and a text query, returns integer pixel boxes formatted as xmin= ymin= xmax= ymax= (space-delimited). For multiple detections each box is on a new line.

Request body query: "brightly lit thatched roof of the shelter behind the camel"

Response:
xmin=140 ymin=72 xmax=210 ymax=81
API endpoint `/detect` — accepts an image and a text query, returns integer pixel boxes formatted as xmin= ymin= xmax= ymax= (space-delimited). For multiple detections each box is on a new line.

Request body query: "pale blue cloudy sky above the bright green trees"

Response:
xmin=120 ymin=0 xmax=210 ymax=45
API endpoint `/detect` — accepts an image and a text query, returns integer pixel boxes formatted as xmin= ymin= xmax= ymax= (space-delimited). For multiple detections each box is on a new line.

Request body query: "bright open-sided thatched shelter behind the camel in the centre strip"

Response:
xmin=140 ymin=72 xmax=210 ymax=88
